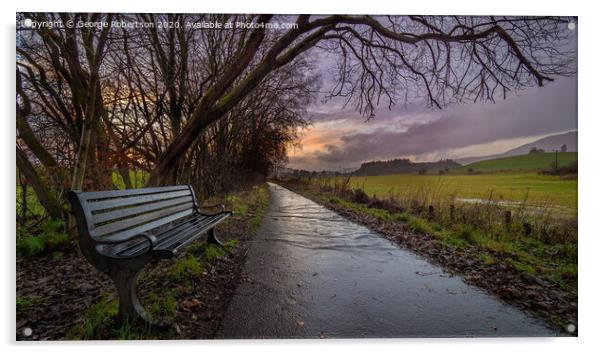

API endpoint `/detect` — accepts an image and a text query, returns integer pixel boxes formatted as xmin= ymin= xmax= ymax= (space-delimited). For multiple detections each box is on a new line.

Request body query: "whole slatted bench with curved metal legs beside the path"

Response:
xmin=67 ymin=185 xmax=232 ymax=324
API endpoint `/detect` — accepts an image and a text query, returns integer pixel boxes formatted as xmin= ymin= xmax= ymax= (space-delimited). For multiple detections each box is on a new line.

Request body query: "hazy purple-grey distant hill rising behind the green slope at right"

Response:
xmin=456 ymin=131 xmax=577 ymax=165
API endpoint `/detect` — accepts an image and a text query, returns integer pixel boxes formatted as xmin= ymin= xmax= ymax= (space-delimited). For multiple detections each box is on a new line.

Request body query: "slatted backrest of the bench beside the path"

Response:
xmin=69 ymin=185 xmax=197 ymax=243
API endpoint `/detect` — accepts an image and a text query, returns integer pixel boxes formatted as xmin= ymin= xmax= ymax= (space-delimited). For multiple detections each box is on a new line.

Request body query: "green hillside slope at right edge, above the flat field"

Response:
xmin=461 ymin=152 xmax=577 ymax=172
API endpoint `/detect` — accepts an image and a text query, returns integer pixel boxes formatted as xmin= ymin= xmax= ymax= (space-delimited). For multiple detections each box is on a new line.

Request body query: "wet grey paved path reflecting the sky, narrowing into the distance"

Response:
xmin=217 ymin=184 xmax=554 ymax=338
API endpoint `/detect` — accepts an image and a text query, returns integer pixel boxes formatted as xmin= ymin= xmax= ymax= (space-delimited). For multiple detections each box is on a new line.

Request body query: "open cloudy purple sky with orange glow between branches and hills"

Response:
xmin=288 ymin=77 xmax=577 ymax=170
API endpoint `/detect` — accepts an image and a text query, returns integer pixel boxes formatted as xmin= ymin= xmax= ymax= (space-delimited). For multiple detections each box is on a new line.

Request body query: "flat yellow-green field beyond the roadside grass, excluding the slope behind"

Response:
xmin=351 ymin=172 xmax=577 ymax=212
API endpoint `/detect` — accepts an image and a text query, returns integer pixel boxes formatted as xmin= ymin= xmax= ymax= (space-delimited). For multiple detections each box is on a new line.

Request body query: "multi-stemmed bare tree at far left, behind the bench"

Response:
xmin=17 ymin=14 xmax=113 ymax=189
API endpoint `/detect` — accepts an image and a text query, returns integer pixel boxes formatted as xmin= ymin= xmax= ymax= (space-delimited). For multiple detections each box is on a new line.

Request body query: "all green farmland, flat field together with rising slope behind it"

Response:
xmin=342 ymin=152 xmax=577 ymax=214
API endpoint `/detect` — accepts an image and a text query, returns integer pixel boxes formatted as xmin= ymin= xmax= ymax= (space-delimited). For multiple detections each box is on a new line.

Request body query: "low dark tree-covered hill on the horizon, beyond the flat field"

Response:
xmin=353 ymin=159 xmax=462 ymax=176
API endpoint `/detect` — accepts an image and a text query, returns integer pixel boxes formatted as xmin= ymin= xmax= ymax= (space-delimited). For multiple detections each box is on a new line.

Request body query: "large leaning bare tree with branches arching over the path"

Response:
xmin=145 ymin=15 xmax=573 ymax=184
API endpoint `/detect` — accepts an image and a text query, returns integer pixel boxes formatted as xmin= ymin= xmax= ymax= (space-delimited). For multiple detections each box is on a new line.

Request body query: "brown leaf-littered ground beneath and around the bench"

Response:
xmin=16 ymin=188 xmax=261 ymax=340
